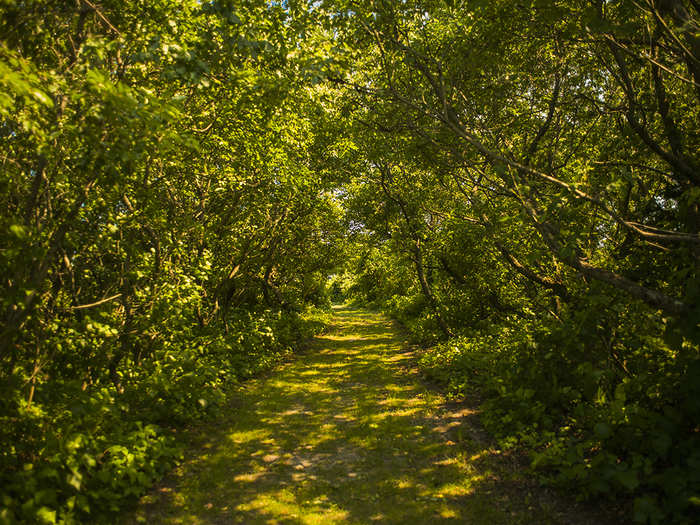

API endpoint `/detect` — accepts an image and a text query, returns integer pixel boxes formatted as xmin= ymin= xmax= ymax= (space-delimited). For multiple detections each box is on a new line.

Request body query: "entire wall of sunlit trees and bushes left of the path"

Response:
xmin=0 ymin=0 xmax=343 ymax=523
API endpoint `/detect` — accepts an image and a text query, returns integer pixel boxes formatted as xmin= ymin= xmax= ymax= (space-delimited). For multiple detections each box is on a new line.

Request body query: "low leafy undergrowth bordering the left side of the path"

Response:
xmin=0 ymin=304 xmax=324 ymax=524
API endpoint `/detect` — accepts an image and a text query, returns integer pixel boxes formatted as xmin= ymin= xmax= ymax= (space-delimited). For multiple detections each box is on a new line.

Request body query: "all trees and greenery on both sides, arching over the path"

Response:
xmin=0 ymin=0 xmax=700 ymax=523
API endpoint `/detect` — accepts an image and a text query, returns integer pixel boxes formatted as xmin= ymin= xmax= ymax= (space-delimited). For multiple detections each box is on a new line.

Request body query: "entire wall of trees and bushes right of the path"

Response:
xmin=330 ymin=1 xmax=700 ymax=523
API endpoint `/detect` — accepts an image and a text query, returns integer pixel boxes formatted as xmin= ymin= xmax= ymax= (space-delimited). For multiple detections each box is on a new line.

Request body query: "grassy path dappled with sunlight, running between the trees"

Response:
xmin=127 ymin=308 xmax=606 ymax=525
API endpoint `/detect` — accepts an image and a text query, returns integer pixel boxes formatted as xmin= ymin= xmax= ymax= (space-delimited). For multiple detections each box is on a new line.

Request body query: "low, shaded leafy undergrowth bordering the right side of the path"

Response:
xmin=346 ymin=283 xmax=700 ymax=524
